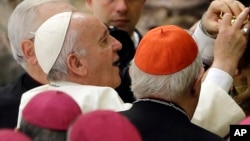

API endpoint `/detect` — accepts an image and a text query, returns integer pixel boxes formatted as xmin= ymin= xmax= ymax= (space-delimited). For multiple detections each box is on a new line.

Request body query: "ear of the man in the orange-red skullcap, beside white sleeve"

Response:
xmin=191 ymin=68 xmax=204 ymax=96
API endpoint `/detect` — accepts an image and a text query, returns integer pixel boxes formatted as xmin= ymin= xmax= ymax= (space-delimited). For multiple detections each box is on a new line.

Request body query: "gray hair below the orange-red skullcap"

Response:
xmin=130 ymin=54 xmax=202 ymax=100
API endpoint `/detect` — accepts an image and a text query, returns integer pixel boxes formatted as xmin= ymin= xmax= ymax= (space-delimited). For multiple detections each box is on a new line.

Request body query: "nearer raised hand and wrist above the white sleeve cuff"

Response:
xmin=212 ymin=8 xmax=250 ymax=76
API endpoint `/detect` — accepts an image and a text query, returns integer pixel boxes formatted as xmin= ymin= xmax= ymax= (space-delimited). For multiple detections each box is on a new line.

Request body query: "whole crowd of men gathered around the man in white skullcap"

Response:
xmin=0 ymin=0 xmax=250 ymax=141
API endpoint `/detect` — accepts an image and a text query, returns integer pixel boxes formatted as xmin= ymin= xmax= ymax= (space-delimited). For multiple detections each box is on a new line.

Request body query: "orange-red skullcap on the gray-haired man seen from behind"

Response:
xmin=135 ymin=25 xmax=198 ymax=75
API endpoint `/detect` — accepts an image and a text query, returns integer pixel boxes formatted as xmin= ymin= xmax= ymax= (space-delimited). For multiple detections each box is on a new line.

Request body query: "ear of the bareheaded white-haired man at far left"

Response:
xmin=21 ymin=39 xmax=37 ymax=65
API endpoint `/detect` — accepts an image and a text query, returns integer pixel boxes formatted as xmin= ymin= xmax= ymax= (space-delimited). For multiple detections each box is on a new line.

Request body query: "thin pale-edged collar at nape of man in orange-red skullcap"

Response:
xmin=133 ymin=98 xmax=190 ymax=119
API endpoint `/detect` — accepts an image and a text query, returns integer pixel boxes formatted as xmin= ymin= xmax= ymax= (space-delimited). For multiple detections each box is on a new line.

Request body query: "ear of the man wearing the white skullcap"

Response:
xmin=67 ymin=53 xmax=88 ymax=76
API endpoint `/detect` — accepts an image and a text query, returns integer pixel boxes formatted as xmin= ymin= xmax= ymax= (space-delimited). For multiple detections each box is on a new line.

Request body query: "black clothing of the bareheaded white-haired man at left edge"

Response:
xmin=0 ymin=73 xmax=42 ymax=128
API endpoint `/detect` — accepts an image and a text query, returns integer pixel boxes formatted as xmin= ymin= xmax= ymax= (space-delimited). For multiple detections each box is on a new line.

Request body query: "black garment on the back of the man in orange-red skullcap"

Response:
xmin=120 ymin=99 xmax=226 ymax=141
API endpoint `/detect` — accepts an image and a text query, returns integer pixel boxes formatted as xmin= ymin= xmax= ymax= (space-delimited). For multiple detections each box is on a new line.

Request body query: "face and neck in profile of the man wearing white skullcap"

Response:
xmin=77 ymin=13 xmax=122 ymax=88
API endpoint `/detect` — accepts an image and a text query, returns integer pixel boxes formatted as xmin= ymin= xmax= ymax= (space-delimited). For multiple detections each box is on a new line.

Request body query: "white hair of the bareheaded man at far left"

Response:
xmin=8 ymin=0 xmax=69 ymax=69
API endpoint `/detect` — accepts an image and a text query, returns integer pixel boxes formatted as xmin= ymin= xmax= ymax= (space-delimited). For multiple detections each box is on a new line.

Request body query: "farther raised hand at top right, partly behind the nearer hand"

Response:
xmin=202 ymin=0 xmax=245 ymax=35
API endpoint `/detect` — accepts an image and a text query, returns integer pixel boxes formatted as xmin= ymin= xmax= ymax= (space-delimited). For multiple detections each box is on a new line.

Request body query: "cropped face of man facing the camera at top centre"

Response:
xmin=87 ymin=0 xmax=145 ymax=34
